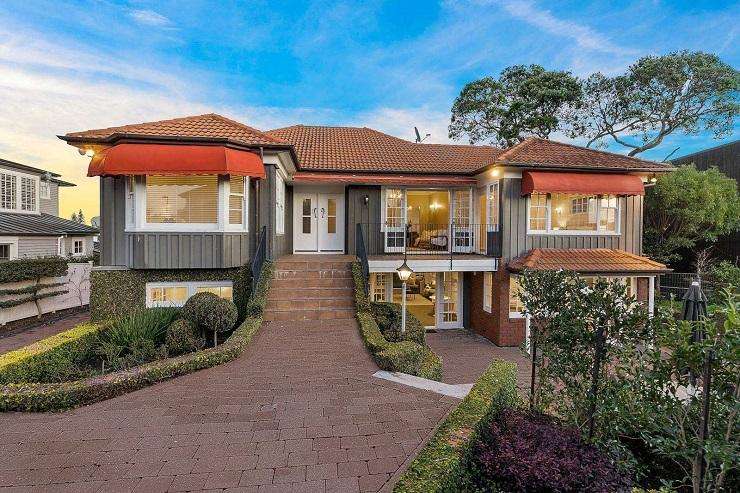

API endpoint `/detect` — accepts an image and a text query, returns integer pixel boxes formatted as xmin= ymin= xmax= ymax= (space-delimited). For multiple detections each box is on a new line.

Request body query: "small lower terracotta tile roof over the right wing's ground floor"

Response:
xmin=508 ymin=248 xmax=670 ymax=273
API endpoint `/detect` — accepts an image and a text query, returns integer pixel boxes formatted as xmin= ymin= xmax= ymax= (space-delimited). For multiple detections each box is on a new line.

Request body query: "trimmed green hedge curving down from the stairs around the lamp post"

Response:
xmin=352 ymin=262 xmax=442 ymax=381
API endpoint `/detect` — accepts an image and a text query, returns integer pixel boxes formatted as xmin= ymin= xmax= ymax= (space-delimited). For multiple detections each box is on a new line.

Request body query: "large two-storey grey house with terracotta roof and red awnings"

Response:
xmin=60 ymin=114 xmax=670 ymax=345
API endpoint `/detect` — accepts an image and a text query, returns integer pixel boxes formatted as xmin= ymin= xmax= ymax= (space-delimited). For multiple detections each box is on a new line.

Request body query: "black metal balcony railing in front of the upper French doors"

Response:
xmin=358 ymin=223 xmax=501 ymax=257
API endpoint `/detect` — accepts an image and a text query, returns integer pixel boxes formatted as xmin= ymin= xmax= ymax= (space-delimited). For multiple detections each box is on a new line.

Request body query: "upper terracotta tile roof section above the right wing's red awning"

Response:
xmin=497 ymin=137 xmax=671 ymax=171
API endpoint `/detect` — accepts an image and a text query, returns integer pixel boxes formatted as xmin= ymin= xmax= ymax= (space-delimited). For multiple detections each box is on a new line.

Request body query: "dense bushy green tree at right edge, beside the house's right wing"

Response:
xmin=644 ymin=166 xmax=740 ymax=263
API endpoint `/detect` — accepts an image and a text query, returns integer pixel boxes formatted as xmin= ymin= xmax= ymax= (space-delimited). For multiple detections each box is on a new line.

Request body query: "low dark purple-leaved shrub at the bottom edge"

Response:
xmin=464 ymin=408 xmax=630 ymax=493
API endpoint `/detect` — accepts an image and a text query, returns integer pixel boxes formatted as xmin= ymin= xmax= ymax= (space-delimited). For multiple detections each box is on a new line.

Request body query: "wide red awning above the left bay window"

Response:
xmin=87 ymin=144 xmax=265 ymax=178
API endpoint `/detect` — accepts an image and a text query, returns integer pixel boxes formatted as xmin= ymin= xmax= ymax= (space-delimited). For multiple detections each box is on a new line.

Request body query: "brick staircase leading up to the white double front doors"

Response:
xmin=264 ymin=255 xmax=355 ymax=322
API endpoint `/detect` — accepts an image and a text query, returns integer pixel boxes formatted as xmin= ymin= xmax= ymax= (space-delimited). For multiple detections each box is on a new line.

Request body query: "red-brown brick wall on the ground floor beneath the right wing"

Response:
xmin=468 ymin=269 xmax=525 ymax=346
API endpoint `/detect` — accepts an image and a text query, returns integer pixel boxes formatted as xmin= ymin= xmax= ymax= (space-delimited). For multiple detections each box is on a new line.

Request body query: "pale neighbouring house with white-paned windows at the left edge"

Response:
xmin=0 ymin=159 xmax=98 ymax=262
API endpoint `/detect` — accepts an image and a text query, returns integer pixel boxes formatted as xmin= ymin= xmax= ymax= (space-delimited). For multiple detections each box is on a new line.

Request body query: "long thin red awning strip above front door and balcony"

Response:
xmin=293 ymin=171 xmax=477 ymax=187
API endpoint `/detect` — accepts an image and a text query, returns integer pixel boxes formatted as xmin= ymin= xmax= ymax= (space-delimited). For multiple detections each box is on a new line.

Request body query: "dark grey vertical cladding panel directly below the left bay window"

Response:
xmin=125 ymin=232 xmax=250 ymax=269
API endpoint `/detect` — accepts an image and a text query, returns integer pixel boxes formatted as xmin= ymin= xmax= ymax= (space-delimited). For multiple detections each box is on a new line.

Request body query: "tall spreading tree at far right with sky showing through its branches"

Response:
xmin=567 ymin=51 xmax=740 ymax=156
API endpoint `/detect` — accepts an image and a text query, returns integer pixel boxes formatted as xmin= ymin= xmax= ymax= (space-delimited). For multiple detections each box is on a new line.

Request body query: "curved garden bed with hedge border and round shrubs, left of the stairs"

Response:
xmin=0 ymin=263 xmax=272 ymax=411
